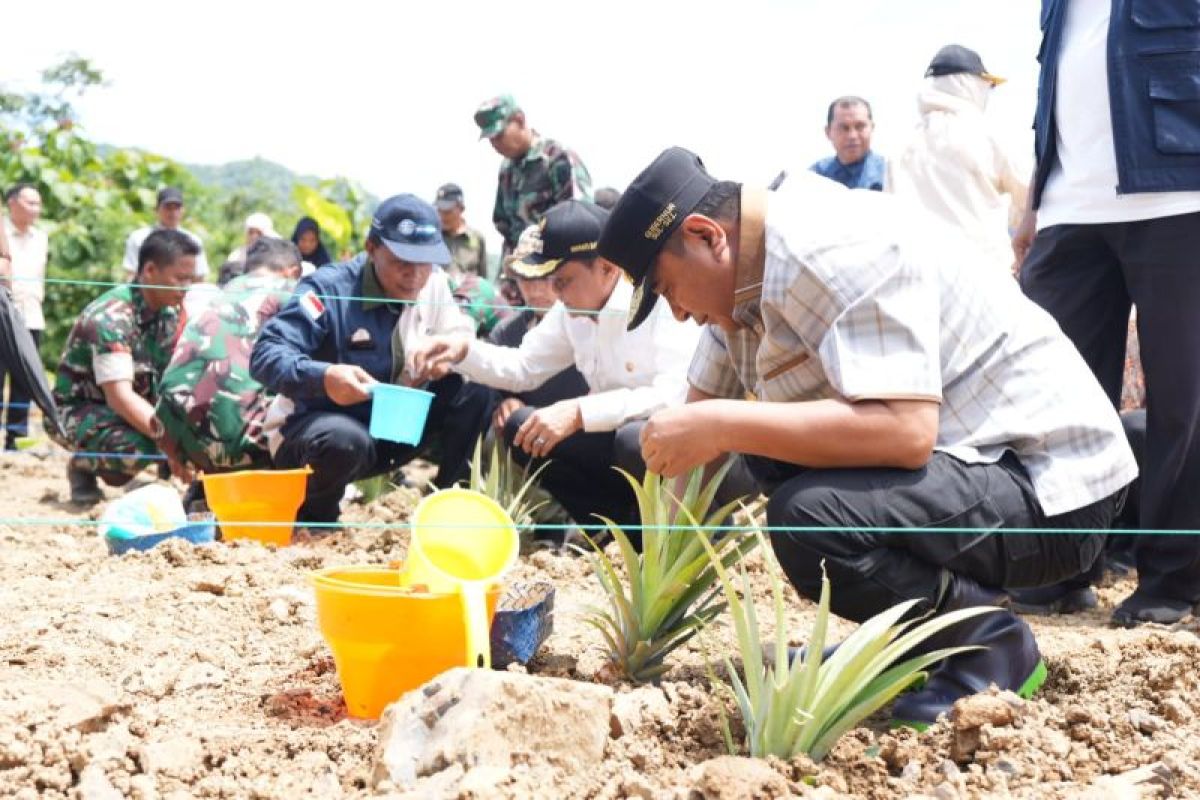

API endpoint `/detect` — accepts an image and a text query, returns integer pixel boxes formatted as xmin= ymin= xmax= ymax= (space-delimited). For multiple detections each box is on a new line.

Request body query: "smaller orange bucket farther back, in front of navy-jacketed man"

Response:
xmin=200 ymin=467 xmax=312 ymax=545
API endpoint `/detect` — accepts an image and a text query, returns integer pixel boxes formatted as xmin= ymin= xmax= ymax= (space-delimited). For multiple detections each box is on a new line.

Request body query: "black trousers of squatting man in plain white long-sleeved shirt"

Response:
xmin=504 ymin=405 xmax=646 ymax=539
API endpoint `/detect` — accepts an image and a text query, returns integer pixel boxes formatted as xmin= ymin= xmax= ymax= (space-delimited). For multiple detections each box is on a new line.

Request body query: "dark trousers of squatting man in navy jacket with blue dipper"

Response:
xmin=275 ymin=375 xmax=494 ymax=523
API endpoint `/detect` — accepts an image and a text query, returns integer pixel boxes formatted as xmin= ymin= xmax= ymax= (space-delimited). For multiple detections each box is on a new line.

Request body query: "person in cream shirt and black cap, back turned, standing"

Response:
xmin=884 ymin=44 xmax=1028 ymax=275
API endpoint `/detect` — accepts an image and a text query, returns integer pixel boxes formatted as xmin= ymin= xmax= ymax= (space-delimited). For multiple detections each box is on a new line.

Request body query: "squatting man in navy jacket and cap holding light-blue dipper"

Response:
xmin=250 ymin=194 xmax=492 ymax=522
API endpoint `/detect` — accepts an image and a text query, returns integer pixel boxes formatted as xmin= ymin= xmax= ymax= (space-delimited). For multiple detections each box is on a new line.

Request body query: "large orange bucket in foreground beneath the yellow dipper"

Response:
xmin=308 ymin=566 xmax=500 ymax=720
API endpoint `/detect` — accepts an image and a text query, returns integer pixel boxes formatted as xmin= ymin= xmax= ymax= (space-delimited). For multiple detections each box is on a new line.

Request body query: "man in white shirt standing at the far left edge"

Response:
xmin=0 ymin=184 xmax=49 ymax=450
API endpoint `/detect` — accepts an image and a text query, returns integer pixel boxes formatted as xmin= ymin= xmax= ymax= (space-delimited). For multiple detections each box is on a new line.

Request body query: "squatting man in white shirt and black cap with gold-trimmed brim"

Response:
xmin=413 ymin=200 xmax=700 ymax=525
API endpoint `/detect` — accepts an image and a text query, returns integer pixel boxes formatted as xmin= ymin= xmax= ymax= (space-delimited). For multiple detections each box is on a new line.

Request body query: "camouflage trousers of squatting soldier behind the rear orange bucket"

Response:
xmin=155 ymin=392 xmax=271 ymax=473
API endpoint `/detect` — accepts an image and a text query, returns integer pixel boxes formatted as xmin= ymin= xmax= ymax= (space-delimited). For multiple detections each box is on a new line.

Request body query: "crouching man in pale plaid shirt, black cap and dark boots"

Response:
xmin=600 ymin=148 xmax=1138 ymax=726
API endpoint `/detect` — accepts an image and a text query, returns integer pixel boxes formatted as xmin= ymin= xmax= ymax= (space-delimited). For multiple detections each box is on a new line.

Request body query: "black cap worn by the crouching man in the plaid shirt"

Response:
xmin=599 ymin=148 xmax=716 ymax=330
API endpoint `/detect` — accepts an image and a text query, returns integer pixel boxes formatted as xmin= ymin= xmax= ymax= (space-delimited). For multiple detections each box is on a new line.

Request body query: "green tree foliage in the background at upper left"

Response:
xmin=0 ymin=55 xmax=373 ymax=367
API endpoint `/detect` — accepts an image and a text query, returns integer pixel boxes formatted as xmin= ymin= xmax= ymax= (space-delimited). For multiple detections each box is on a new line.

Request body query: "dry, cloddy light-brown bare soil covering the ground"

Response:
xmin=0 ymin=456 xmax=1200 ymax=800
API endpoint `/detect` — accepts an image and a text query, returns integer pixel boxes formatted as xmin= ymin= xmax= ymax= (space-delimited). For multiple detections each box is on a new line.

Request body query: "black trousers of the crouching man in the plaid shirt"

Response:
xmin=748 ymin=452 xmax=1116 ymax=621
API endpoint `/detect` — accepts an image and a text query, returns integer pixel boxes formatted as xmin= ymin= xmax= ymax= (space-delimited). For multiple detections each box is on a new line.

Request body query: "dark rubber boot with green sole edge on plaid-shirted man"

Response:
xmin=892 ymin=610 xmax=1046 ymax=730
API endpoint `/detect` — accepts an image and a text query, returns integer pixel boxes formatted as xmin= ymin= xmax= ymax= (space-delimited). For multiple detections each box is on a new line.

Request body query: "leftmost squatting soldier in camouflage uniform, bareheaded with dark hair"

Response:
xmin=54 ymin=230 xmax=199 ymax=505
